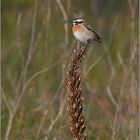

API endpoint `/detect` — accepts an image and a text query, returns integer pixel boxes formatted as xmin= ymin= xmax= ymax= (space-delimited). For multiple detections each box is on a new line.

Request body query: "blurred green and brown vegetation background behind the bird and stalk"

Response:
xmin=1 ymin=0 xmax=139 ymax=140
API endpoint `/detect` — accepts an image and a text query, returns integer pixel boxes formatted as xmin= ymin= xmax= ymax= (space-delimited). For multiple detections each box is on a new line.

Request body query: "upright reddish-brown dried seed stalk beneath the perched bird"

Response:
xmin=67 ymin=47 xmax=87 ymax=140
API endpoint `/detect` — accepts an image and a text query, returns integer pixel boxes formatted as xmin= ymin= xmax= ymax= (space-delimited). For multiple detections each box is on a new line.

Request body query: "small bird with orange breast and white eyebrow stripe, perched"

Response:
xmin=72 ymin=19 xmax=102 ymax=45
